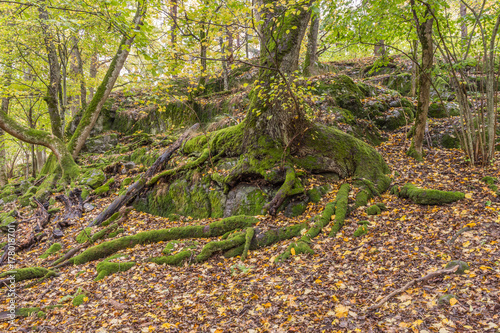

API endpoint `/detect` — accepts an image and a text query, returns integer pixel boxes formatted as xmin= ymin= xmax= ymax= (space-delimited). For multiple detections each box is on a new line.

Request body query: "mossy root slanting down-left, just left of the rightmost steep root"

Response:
xmin=275 ymin=202 xmax=336 ymax=262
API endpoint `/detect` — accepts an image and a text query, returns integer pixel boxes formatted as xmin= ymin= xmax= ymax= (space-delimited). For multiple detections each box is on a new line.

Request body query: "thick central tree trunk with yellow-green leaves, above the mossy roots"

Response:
xmin=245 ymin=0 xmax=313 ymax=146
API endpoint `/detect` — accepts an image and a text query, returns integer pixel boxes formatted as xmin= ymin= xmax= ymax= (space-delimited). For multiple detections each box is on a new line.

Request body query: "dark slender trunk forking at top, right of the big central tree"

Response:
xmin=408 ymin=0 xmax=434 ymax=160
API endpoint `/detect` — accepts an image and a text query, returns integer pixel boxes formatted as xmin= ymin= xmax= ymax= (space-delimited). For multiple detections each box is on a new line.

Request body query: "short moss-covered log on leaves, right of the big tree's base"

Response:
xmin=399 ymin=183 xmax=465 ymax=205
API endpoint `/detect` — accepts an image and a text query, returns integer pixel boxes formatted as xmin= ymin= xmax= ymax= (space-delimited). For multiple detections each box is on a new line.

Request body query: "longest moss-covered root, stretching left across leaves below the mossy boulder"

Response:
xmin=70 ymin=216 xmax=258 ymax=265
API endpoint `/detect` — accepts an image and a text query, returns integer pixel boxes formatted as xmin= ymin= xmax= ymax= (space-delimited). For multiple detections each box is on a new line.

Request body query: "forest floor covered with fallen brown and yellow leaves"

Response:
xmin=0 ymin=123 xmax=500 ymax=333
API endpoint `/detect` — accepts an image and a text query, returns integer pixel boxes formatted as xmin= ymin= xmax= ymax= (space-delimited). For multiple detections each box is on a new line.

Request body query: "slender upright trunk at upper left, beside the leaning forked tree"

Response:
xmin=38 ymin=3 xmax=64 ymax=139
